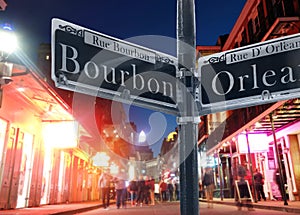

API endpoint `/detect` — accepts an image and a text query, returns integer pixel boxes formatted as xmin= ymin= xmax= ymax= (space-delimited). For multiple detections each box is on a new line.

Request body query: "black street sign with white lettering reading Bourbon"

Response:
xmin=51 ymin=19 xmax=177 ymax=114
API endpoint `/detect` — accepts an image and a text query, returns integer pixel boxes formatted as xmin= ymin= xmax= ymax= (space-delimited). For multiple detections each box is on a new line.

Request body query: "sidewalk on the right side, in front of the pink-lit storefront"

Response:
xmin=199 ymin=198 xmax=300 ymax=214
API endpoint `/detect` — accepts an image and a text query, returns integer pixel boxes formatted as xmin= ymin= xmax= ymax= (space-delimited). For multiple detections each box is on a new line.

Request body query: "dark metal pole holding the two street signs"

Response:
xmin=177 ymin=0 xmax=200 ymax=215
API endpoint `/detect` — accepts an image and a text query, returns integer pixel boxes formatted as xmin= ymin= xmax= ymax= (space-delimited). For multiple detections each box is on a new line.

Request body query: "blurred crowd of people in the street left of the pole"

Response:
xmin=98 ymin=172 xmax=179 ymax=209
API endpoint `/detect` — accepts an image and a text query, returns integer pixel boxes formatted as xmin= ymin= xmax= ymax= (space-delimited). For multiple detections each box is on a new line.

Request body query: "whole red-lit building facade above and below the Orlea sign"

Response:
xmin=198 ymin=0 xmax=300 ymax=200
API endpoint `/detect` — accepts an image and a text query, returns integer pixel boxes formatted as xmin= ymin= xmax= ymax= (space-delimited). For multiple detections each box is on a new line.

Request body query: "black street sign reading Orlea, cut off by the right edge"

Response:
xmin=198 ymin=34 xmax=300 ymax=115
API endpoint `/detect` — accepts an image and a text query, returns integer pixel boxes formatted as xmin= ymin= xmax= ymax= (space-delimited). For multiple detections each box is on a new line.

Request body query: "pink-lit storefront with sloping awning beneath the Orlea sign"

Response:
xmin=200 ymin=99 xmax=300 ymax=201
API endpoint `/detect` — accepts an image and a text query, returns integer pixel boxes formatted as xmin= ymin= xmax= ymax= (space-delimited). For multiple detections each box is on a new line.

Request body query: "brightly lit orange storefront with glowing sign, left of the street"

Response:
xmin=0 ymin=65 xmax=99 ymax=209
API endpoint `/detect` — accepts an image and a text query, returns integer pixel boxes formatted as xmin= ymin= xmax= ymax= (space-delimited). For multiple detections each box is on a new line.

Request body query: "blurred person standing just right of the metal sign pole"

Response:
xmin=202 ymin=167 xmax=214 ymax=208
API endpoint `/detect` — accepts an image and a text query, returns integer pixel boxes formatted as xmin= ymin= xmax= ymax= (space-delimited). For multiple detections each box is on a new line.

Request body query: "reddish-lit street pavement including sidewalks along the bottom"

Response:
xmin=0 ymin=198 xmax=300 ymax=215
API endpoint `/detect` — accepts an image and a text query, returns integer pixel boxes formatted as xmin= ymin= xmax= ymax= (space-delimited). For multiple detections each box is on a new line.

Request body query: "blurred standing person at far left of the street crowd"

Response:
xmin=98 ymin=171 xmax=111 ymax=209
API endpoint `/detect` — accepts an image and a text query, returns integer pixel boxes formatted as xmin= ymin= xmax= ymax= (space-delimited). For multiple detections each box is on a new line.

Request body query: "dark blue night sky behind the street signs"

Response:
xmin=0 ymin=0 xmax=246 ymax=155
